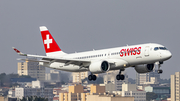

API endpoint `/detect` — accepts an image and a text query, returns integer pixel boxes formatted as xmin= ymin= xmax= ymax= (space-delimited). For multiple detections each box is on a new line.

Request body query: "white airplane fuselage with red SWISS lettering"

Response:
xmin=43 ymin=43 xmax=171 ymax=72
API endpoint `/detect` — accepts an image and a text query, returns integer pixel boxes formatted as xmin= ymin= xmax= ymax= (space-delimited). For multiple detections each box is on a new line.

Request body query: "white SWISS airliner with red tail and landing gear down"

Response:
xmin=13 ymin=26 xmax=172 ymax=81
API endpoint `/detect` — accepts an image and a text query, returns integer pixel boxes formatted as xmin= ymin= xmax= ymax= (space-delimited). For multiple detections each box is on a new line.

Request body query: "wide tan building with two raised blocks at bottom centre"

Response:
xmin=59 ymin=85 xmax=134 ymax=101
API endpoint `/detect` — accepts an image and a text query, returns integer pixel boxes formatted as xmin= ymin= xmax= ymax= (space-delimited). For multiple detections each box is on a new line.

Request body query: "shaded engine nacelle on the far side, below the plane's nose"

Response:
xmin=134 ymin=64 xmax=154 ymax=73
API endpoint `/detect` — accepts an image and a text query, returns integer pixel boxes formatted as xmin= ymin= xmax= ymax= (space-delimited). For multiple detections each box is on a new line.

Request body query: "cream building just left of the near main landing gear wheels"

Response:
xmin=72 ymin=71 xmax=89 ymax=83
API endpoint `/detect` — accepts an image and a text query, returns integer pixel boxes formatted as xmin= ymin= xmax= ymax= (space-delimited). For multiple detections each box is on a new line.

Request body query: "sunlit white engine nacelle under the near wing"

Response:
xmin=89 ymin=61 xmax=110 ymax=74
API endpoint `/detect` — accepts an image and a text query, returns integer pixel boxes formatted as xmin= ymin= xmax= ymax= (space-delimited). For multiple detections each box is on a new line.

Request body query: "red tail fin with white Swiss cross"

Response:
xmin=39 ymin=26 xmax=65 ymax=56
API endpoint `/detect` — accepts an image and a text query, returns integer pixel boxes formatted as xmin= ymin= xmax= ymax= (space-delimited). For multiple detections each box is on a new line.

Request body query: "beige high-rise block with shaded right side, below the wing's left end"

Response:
xmin=17 ymin=58 xmax=45 ymax=81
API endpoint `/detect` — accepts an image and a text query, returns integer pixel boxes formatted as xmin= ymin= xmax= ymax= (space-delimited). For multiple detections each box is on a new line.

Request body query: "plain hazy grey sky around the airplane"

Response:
xmin=0 ymin=0 xmax=180 ymax=78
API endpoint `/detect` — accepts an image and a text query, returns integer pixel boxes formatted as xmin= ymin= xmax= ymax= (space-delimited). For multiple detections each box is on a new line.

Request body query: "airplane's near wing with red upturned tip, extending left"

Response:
xmin=13 ymin=47 xmax=91 ymax=67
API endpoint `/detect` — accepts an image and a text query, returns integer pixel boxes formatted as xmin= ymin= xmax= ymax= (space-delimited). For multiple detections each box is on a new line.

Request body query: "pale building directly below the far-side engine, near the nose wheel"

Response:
xmin=136 ymin=69 xmax=160 ymax=85
